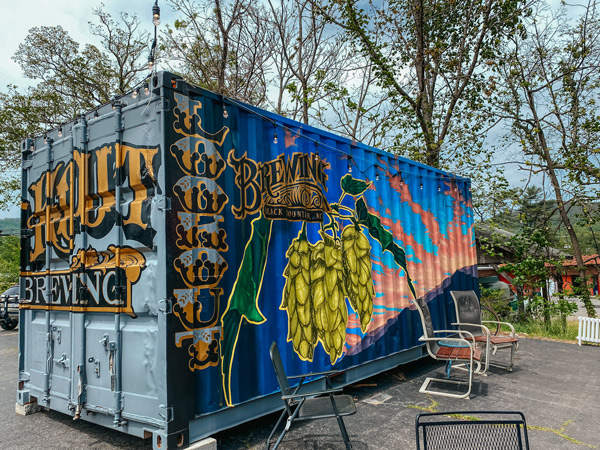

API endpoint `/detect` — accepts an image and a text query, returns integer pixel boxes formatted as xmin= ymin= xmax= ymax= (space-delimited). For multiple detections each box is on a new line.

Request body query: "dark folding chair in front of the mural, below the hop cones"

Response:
xmin=266 ymin=342 xmax=356 ymax=450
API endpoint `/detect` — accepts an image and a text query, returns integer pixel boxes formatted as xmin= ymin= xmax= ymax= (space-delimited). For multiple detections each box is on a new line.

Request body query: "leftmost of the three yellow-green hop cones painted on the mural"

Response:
xmin=281 ymin=239 xmax=317 ymax=361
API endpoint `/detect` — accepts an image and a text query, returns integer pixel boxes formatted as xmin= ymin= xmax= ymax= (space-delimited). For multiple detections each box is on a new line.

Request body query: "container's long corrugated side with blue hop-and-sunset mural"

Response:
xmin=161 ymin=78 xmax=476 ymax=414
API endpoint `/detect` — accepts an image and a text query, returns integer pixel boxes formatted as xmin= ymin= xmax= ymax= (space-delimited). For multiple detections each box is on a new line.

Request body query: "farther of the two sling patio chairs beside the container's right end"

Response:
xmin=450 ymin=291 xmax=519 ymax=374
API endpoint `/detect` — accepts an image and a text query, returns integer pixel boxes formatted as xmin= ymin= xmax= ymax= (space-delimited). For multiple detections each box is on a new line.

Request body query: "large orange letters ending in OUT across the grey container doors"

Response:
xmin=23 ymin=144 xmax=160 ymax=270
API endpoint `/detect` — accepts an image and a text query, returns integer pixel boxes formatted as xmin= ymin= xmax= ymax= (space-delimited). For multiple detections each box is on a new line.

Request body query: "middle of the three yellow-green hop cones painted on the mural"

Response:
xmin=311 ymin=235 xmax=348 ymax=364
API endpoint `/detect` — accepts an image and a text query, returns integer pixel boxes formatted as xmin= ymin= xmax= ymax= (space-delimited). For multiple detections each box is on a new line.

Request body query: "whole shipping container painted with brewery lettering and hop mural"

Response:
xmin=17 ymin=72 xmax=477 ymax=448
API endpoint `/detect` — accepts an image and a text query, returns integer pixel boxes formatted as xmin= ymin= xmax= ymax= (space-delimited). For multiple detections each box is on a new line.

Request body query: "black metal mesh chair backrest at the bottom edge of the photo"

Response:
xmin=415 ymin=411 xmax=529 ymax=450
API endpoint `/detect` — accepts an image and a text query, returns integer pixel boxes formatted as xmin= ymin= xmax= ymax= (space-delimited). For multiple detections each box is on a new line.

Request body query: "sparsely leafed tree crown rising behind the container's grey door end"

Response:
xmin=13 ymin=8 xmax=149 ymax=109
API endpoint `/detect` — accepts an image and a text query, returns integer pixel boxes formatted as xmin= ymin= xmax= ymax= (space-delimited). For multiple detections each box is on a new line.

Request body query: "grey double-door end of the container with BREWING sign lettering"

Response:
xmin=19 ymin=97 xmax=167 ymax=435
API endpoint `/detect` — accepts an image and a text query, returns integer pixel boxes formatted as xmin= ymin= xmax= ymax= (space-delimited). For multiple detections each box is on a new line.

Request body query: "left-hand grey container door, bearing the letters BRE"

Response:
xmin=20 ymin=129 xmax=74 ymax=410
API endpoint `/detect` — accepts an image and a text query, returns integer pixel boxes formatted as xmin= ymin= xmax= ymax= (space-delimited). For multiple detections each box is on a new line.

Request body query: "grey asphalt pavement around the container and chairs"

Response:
xmin=0 ymin=331 xmax=600 ymax=450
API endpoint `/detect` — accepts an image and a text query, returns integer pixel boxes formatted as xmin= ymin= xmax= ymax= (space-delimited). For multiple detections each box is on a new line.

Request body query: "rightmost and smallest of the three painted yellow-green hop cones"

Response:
xmin=342 ymin=225 xmax=375 ymax=333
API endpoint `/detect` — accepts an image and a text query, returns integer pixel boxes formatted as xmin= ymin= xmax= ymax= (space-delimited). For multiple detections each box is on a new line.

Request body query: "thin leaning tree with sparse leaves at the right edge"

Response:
xmin=497 ymin=0 xmax=600 ymax=317
